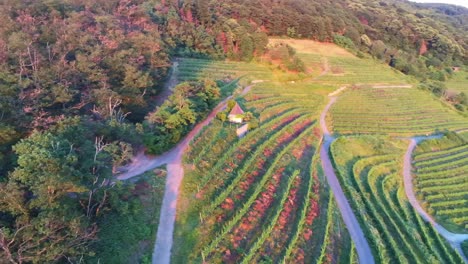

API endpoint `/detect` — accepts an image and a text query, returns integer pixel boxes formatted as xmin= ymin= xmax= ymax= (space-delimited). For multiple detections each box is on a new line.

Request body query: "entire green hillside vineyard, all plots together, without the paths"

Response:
xmin=164 ymin=40 xmax=468 ymax=263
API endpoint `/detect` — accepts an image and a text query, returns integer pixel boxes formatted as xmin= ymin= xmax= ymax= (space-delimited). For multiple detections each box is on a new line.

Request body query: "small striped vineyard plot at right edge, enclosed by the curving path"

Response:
xmin=413 ymin=134 xmax=468 ymax=232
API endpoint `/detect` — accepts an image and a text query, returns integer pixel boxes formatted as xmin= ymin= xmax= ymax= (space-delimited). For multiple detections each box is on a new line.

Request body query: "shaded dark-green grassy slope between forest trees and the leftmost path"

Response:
xmin=87 ymin=169 xmax=166 ymax=263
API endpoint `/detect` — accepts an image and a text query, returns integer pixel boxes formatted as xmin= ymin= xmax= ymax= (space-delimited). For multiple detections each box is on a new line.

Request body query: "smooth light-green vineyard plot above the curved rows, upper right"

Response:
xmin=327 ymin=88 xmax=468 ymax=135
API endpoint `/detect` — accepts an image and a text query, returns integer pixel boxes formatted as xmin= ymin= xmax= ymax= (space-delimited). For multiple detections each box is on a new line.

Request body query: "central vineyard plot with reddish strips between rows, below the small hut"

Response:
xmin=172 ymin=83 xmax=356 ymax=263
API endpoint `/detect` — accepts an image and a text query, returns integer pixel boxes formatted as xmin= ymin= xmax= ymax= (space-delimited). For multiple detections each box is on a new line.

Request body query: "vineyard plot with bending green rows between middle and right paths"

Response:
xmin=331 ymin=136 xmax=463 ymax=263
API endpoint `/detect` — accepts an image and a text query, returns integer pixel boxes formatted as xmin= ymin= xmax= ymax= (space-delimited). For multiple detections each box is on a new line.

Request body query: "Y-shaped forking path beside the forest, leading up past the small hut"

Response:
xmin=117 ymin=85 xmax=253 ymax=264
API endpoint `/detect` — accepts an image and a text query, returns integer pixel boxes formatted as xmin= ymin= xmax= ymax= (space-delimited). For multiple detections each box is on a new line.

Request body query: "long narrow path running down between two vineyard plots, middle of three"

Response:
xmin=320 ymin=97 xmax=374 ymax=264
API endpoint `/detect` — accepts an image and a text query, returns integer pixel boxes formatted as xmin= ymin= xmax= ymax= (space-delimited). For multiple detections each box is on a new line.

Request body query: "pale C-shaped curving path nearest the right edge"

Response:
xmin=403 ymin=136 xmax=468 ymax=263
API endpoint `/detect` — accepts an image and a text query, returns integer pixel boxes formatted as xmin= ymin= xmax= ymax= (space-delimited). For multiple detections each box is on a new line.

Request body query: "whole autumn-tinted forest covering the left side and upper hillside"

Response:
xmin=0 ymin=0 xmax=468 ymax=263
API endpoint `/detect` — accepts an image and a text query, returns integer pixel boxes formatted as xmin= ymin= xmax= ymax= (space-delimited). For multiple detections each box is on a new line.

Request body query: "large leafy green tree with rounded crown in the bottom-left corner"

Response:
xmin=0 ymin=133 xmax=97 ymax=263
